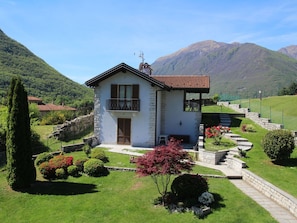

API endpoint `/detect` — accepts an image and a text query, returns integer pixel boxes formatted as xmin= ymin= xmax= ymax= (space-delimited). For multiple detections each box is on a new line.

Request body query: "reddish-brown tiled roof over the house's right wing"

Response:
xmin=151 ymin=75 xmax=210 ymax=93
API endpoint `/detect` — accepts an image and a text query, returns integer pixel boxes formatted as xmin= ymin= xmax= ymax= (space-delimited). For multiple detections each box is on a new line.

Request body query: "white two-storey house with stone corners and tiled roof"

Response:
xmin=86 ymin=63 xmax=210 ymax=147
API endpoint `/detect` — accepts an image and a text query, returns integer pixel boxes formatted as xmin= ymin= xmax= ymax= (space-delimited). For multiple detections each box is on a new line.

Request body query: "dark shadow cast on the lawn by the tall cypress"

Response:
xmin=20 ymin=181 xmax=99 ymax=195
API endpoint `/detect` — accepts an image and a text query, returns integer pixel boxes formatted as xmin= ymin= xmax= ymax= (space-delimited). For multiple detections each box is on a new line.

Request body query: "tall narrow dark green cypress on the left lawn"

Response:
xmin=6 ymin=77 xmax=36 ymax=190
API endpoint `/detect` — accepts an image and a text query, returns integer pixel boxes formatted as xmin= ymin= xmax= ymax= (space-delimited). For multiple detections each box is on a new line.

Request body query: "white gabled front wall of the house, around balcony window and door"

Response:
xmin=94 ymin=72 xmax=158 ymax=146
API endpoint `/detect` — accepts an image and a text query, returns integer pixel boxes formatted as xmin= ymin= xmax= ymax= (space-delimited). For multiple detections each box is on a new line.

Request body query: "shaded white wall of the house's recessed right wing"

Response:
xmin=161 ymin=90 xmax=201 ymax=144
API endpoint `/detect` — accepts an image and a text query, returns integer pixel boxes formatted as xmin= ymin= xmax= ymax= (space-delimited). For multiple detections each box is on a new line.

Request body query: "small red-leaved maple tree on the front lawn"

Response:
xmin=136 ymin=139 xmax=193 ymax=204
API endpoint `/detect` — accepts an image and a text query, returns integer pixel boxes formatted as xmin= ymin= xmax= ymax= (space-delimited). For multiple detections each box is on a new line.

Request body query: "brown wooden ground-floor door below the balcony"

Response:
xmin=117 ymin=118 xmax=131 ymax=145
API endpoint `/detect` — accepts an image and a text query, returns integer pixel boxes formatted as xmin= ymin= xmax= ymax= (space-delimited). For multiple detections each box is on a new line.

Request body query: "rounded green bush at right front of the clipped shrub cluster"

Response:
xmin=84 ymin=158 xmax=108 ymax=177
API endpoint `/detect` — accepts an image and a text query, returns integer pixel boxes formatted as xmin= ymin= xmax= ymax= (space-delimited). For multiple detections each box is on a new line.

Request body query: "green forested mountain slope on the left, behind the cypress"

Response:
xmin=0 ymin=29 xmax=93 ymax=104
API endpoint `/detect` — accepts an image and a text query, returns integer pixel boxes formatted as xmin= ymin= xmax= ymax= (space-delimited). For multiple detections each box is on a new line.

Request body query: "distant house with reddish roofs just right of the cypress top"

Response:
xmin=28 ymin=96 xmax=76 ymax=115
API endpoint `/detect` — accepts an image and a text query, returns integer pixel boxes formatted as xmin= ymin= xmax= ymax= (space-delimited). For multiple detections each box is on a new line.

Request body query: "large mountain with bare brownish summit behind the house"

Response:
xmin=151 ymin=40 xmax=297 ymax=98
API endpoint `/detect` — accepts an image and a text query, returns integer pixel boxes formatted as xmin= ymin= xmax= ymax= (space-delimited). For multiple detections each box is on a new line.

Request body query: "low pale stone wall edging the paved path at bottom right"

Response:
xmin=242 ymin=169 xmax=297 ymax=217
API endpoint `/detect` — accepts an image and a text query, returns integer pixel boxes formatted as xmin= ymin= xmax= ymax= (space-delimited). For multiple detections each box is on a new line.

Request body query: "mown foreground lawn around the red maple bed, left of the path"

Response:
xmin=0 ymin=162 xmax=276 ymax=223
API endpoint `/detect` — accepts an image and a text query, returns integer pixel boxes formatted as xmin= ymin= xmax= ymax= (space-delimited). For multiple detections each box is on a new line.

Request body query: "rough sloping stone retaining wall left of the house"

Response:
xmin=50 ymin=113 xmax=94 ymax=140
